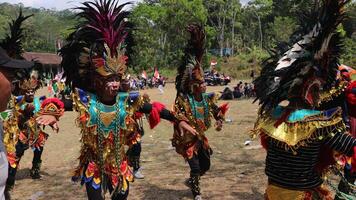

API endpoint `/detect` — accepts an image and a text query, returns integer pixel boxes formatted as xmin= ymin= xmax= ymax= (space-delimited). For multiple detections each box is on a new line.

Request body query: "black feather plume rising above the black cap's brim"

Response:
xmin=0 ymin=9 xmax=33 ymax=59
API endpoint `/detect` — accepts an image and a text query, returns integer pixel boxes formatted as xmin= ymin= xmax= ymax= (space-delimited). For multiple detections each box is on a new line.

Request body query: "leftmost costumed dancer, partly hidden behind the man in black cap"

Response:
xmin=0 ymin=11 xmax=63 ymax=199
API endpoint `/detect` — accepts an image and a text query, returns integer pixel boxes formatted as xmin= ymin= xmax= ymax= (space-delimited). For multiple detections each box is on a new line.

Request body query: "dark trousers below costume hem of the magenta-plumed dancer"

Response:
xmin=85 ymin=182 xmax=129 ymax=200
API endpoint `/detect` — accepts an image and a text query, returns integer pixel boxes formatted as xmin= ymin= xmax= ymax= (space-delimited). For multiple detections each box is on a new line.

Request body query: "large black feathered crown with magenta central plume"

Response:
xmin=60 ymin=0 xmax=130 ymax=90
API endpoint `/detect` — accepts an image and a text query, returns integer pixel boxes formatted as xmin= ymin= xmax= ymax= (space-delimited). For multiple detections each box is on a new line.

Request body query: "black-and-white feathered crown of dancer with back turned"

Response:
xmin=254 ymin=0 xmax=349 ymax=112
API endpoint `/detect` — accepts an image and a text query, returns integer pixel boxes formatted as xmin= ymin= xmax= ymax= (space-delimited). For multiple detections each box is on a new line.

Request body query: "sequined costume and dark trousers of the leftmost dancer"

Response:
xmin=4 ymin=96 xmax=64 ymax=179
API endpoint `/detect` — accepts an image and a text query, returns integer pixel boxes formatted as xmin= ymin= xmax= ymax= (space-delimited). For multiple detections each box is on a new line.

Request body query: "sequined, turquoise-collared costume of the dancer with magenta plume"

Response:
xmin=73 ymin=89 xmax=159 ymax=191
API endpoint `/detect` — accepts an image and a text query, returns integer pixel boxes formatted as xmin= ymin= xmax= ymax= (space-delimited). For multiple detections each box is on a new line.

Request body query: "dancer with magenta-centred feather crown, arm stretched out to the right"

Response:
xmin=60 ymin=0 xmax=195 ymax=200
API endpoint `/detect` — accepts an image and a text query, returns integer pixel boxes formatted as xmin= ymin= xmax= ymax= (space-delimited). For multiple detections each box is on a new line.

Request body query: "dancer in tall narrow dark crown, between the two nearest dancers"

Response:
xmin=172 ymin=24 xmax=228 ymax=200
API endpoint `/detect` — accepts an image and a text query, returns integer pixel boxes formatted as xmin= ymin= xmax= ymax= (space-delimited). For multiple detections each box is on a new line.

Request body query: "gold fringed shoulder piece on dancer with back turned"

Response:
xmin=253 ymin=108 xmax=346 ymax=150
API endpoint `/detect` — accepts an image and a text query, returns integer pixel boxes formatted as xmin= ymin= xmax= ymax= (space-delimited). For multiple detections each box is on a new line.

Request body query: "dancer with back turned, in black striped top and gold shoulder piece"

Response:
xmin=254 ymin=0 xmax=356 ymax=200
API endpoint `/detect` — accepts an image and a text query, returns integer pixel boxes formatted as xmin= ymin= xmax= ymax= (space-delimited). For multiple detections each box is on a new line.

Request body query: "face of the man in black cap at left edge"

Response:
xmin=0 ymin=67 xmax=15 ymax=112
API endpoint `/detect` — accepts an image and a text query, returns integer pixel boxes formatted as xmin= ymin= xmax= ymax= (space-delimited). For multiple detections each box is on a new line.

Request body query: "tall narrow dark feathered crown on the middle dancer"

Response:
xmin=176 ymin=24 xmax=205 ymax=94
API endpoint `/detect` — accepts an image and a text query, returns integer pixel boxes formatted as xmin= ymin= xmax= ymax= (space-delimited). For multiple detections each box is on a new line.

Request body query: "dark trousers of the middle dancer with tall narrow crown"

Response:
xmin=188 ymin=143 xmax=211 ymax=176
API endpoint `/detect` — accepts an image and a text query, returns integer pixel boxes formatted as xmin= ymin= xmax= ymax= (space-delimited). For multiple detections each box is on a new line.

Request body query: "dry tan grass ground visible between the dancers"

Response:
xmin=12 ymin=81 xmax=266 ymax=200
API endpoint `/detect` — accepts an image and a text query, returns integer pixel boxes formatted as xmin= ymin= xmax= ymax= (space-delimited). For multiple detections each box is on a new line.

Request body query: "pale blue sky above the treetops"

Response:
xmin=0 ymin=0 xmax=249 ymax=10
